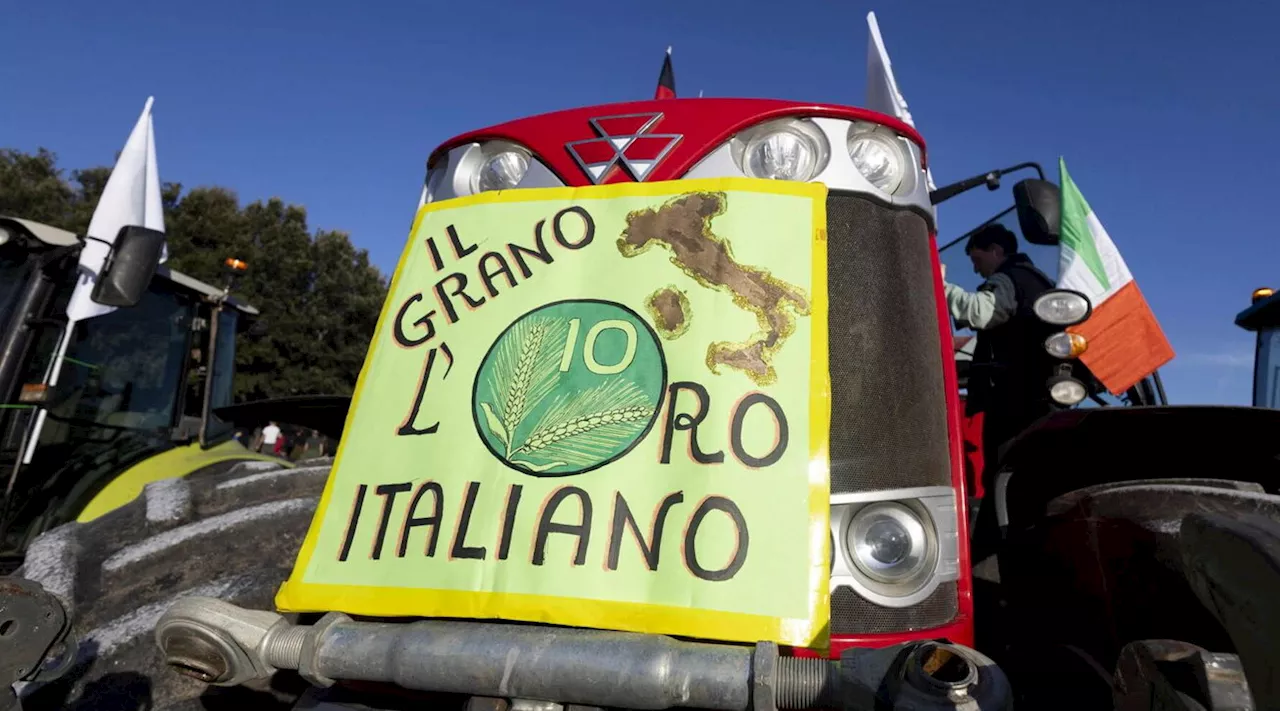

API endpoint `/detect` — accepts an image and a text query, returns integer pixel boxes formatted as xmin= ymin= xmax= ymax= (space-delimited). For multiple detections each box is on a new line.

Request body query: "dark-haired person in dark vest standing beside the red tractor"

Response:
xmin=942 ymin=223 xmax=1053 ymax=491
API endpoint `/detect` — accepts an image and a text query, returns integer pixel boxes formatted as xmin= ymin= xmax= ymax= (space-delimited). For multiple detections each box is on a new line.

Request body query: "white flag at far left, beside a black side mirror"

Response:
xmin=67 ymin=97 xmax=169 ymax=323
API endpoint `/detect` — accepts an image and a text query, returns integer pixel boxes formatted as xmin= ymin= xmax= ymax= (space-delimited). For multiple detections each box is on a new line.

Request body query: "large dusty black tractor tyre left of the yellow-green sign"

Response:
xmin=15 ymin=459 xmax=332 ymax=711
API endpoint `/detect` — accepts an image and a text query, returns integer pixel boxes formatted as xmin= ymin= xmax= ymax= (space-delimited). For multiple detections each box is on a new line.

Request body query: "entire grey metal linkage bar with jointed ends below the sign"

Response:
xmin=155 ymin=597 xmax=1011 ymax=711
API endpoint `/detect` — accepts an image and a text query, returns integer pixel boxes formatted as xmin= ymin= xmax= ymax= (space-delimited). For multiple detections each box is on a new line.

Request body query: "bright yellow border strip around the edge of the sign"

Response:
xmin=275 ymin=178 xmax=831 ymax=648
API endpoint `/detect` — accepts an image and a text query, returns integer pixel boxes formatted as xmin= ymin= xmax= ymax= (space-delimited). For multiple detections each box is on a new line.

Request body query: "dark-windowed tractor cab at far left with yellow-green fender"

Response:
xmin=0 ymin=218 xmax=257 ymax=568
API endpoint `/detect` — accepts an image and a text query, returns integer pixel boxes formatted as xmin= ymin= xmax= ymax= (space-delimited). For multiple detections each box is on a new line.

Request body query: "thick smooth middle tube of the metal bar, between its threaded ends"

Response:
xmin=314 ymin=620 xmax=757 ymax=711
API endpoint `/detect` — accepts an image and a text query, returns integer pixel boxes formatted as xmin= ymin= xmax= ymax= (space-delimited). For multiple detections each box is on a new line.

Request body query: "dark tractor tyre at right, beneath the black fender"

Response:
xmin=998 ymin=479 xmax=1280 ymax=708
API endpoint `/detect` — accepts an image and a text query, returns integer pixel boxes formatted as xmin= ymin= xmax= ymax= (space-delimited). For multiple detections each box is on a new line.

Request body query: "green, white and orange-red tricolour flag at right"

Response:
xmin=1057 ymin=159 xmax=1174 ymax=395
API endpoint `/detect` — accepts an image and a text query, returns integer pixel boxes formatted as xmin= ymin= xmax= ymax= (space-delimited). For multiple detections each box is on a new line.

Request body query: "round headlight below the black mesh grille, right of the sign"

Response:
xmin=846 ymin=502 xmax=932 ymax=583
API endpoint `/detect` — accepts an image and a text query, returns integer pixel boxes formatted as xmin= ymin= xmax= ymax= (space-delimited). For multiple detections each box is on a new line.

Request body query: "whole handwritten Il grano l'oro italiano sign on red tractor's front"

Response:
xmin=276 ymin=178 xmax=829 ymax=647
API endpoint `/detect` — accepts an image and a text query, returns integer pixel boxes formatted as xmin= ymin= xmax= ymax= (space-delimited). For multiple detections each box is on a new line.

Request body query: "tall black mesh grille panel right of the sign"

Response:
xmin=827 ymin=192 xmax=951 ymax=493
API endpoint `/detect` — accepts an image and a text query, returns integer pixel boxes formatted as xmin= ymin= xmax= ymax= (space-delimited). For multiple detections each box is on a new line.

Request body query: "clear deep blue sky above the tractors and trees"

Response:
xmin=0 ymin=0 xmax=1280 ymax=404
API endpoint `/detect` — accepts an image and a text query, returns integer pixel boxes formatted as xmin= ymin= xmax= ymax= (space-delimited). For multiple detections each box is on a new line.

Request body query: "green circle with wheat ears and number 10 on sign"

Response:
xmin=471 ymin=298 xmax=667 ymax=477
